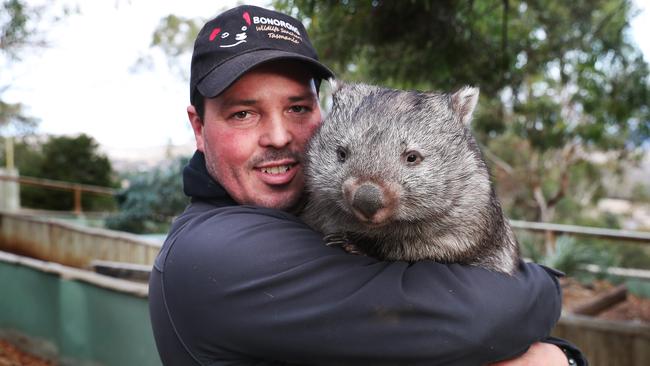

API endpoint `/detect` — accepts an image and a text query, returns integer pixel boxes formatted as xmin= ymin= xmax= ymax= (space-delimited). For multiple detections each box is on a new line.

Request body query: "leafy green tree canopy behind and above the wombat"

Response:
xmin=274 ymin=0 xmax=650 ymax=247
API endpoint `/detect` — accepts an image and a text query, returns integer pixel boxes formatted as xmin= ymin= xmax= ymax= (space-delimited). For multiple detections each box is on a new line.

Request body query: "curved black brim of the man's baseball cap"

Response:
xmin=196 ymin=50 xmax=334 ymax=98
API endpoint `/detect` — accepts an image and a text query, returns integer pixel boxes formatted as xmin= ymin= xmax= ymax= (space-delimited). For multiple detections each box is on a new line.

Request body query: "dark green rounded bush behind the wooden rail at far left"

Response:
xmin=6 ymin=134 xmax=115 ymax=211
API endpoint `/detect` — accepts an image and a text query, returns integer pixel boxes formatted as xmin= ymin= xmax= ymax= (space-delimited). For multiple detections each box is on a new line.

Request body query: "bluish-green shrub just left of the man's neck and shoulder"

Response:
xmin=106 ymin=158 xmax=188 ymax=233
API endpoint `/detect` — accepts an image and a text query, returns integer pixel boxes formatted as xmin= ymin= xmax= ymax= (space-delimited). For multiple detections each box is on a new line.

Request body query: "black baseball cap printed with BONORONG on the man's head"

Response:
xmin=190 ymin=5 xmax=334 ymax=105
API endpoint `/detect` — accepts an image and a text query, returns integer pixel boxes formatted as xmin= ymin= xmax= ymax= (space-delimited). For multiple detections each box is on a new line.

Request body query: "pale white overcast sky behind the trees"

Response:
xmin=0 ymin=0 xmax=650 ymax=154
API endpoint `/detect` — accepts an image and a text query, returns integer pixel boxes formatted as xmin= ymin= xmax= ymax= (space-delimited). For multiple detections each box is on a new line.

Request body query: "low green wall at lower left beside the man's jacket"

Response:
xmin=0 ymin=261 xmax=160 ymax=366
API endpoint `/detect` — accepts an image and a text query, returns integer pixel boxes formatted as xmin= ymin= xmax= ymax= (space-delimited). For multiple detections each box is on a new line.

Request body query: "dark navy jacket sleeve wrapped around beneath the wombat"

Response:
xmin=156 ymin=206 xmax=561 ymax=365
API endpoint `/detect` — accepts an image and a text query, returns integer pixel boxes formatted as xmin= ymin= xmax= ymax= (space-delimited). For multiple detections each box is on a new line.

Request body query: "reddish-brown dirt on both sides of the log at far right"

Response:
xmin=560 ymin=278 xmax=650 ymax=323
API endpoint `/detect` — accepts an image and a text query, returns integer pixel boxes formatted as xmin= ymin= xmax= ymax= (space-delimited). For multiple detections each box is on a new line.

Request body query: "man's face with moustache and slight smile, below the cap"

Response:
xmin=188 ymin=62 xmax=321 ymax=209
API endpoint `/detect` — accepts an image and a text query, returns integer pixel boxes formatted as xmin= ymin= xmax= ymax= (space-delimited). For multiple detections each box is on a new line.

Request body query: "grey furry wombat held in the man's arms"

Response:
xmin=301 ymin=82 xmax=519 ymax=274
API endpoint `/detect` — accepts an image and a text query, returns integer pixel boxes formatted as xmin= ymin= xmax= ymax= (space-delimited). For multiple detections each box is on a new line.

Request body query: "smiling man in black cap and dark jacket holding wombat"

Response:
xmin=150 ymin=6 xmax=581 ymax=365
